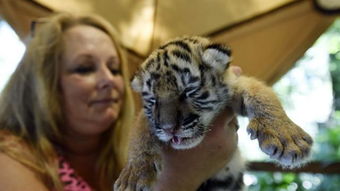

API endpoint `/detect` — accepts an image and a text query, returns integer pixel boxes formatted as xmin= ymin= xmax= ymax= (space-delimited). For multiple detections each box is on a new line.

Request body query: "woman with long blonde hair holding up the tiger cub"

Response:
xmin=0 ymin=14 xmax=236 ymax=191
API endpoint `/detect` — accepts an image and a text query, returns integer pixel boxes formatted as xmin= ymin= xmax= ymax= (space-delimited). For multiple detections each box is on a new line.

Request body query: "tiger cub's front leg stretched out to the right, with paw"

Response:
xmin=227 ymin=73 xmax=313 ymax=167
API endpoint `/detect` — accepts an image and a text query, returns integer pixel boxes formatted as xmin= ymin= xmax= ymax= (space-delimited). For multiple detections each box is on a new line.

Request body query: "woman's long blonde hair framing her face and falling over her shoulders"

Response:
xmin=0 ymin=13 xmax=135 ymax=190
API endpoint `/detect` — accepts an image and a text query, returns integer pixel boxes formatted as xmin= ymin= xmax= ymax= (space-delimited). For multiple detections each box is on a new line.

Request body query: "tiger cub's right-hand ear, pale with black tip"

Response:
xmin=202 ymin=44 xmax=231 ymax=72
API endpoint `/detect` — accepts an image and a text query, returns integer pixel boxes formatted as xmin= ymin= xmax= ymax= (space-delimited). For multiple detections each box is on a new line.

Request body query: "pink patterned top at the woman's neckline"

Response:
xmin=58 ymin=155 xmax=93 ymax=191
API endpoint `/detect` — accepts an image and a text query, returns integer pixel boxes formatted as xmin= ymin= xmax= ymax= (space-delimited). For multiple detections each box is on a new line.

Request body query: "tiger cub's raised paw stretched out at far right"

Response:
xmin=247 ymin=118 xmax=313 ymax=168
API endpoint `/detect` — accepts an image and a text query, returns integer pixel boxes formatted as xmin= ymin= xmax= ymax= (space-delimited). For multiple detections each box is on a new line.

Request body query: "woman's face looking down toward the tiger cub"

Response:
xmin=60 ymin=25 xmax=124 ymax=135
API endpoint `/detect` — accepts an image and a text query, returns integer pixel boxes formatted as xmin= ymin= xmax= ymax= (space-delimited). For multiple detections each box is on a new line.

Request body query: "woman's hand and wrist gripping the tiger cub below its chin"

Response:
xmin=154 ymin=66 xmax=242 ymax=191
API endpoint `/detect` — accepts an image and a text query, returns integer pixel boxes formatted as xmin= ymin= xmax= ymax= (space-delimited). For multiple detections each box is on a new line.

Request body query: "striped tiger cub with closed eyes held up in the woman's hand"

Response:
xmin=114 ymin=37 xmax=313 ymax=191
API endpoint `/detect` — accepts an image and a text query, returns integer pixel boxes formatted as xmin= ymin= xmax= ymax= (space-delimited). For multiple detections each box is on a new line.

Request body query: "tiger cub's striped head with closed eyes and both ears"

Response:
xmin=132 ymin=37 xmax=230 ymax=149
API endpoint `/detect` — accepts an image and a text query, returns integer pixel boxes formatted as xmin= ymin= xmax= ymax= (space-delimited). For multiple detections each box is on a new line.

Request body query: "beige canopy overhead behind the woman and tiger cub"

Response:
xmin=0 ymin=0 xmax=340 ymax=84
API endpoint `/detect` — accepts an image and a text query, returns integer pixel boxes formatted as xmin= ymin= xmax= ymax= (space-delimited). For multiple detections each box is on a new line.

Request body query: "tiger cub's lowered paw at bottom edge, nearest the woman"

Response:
xmin=113 ymin=161 xmax=156 ymax=191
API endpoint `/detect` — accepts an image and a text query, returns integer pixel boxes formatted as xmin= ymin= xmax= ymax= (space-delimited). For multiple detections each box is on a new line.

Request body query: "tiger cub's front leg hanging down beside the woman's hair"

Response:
xmin=114 ymin=114 xmax=160 ymax=191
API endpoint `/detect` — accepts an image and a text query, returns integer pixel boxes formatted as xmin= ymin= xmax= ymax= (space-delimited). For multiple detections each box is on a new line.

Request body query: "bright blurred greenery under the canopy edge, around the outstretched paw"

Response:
xmin=239 ymin=19 xmax=340 ymax=191
